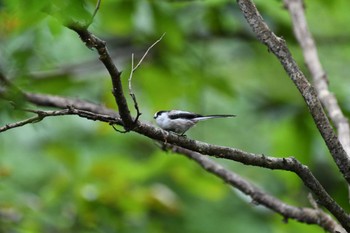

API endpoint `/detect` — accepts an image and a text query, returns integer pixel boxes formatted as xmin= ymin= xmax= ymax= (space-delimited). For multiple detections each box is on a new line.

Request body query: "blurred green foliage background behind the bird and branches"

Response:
xmin=0 ymin=0 xmax=350 ymax=233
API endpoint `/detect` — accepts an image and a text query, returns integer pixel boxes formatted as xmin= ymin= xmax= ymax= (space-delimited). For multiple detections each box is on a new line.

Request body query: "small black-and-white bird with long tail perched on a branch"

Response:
xmin=154 ymin=110 xmax=236 ymax=135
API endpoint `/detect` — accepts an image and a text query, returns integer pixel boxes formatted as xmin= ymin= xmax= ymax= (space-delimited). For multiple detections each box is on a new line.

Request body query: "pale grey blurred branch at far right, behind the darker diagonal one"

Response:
xmin=284 ymin=0 xmax=350 ymax=156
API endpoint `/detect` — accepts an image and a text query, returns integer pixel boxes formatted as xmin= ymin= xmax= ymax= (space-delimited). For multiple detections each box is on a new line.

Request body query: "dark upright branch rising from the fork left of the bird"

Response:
xmin=68 ymin=24 xmax=137 ymax=131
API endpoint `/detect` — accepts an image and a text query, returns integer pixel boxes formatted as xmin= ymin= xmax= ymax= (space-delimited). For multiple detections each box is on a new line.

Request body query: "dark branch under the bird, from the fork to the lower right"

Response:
xmin=134 ymin=124 xmax=350 ymax=232
